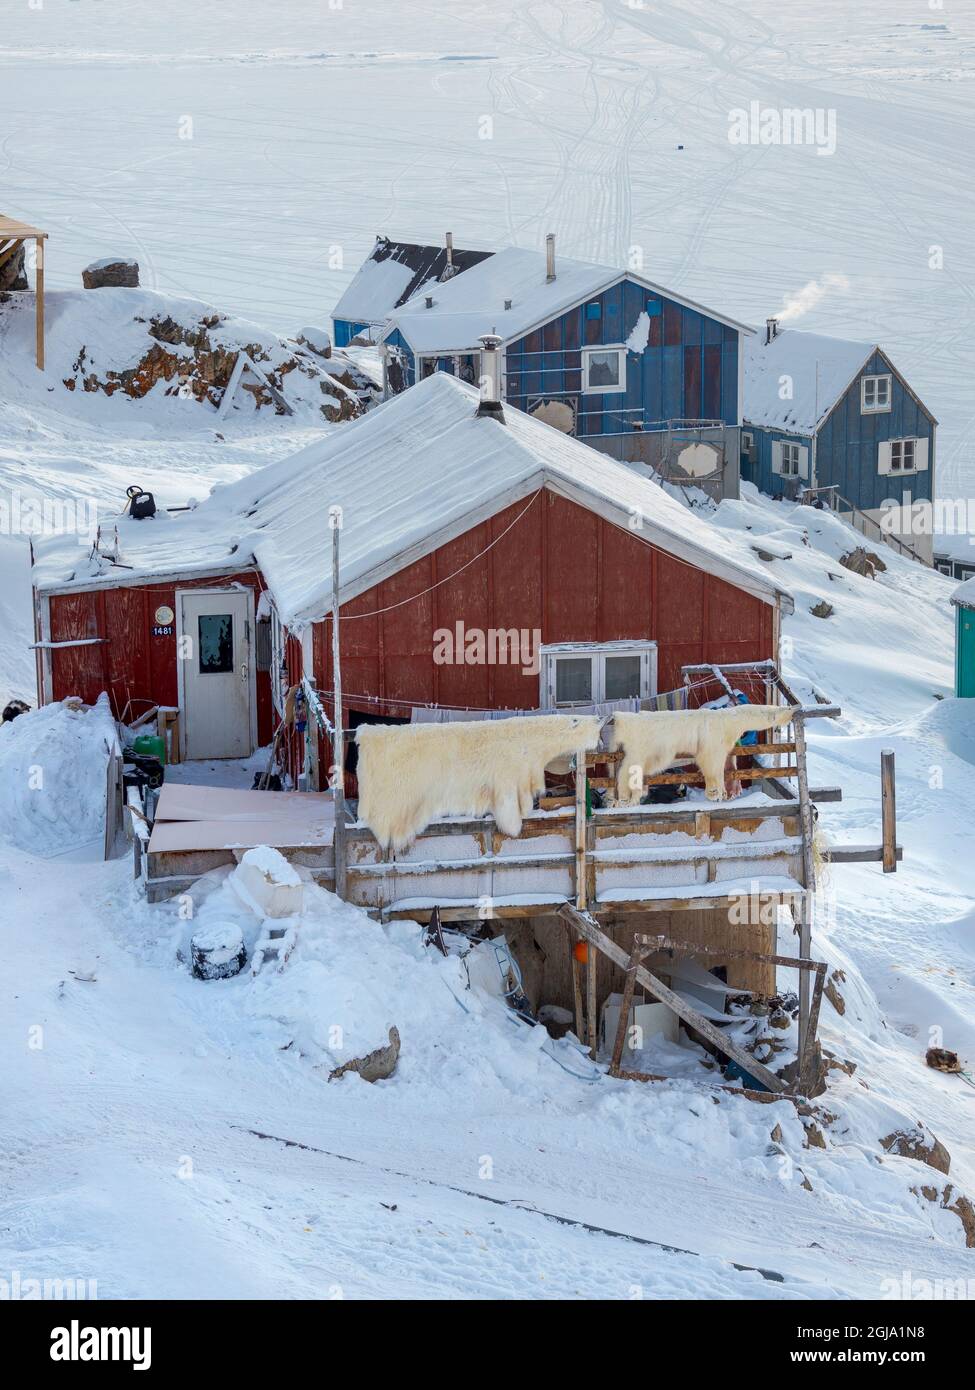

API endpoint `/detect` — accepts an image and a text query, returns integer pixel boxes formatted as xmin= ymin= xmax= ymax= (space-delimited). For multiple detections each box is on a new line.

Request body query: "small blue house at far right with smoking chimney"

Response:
xmin=741 ymin=318 xmax=937 ymax=564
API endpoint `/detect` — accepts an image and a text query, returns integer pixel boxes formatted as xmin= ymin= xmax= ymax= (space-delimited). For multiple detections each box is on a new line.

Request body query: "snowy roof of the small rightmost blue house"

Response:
xmin=743 ymin=328 xmax=876 ymax=434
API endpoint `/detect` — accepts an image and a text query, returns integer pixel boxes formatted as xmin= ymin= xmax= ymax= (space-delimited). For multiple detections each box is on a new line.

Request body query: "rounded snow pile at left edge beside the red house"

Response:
xmin=0 ymin=696 xmax=115 ymax=858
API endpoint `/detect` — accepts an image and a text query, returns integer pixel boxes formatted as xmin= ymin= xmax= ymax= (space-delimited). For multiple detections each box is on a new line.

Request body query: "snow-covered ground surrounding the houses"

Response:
xmin=0 ymin=0 xmax=975 ymax=1298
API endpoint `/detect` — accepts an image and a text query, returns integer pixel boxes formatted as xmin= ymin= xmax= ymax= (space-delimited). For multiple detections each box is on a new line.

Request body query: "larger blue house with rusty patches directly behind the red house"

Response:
xmin=381 ymin=238 xmax=752 ymax=496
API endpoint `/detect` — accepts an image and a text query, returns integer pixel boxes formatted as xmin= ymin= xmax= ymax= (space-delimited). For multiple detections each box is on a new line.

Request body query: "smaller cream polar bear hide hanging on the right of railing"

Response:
xmin=612 ymin=705 xmax=793 ymax=803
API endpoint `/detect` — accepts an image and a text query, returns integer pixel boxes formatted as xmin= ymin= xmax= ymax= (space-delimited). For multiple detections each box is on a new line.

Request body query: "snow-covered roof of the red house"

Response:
xmin=35 ymin=373 xmax=791 ymax=627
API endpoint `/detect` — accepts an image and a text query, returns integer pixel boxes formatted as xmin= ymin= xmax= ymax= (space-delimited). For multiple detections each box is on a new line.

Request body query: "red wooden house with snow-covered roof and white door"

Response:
xmin=33 ymin=374 xmax=791 ymax=785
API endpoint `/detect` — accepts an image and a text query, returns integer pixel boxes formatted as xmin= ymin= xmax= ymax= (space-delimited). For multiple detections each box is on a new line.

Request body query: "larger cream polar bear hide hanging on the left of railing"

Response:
xmin=356 ymin=714 xmax=602 ymax=849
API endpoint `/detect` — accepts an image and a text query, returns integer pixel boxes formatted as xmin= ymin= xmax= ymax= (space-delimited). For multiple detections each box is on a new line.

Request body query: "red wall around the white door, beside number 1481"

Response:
xmin=39 ymin=573 xmax=271 ymax=744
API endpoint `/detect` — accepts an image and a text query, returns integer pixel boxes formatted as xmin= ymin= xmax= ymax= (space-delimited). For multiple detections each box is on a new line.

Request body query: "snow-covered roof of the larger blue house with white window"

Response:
xmin=384 ymin=246 xmax=752 ymax=353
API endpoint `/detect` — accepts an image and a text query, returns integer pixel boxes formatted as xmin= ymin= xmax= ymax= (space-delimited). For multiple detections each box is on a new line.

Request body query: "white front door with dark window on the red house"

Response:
xmin=177 ymin=589 xmax=253 ymax=758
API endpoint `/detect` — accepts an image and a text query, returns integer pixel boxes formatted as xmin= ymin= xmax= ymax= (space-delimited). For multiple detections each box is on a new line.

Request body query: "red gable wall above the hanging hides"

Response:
xmin=307 ymin=491 xmax=776 ymax=778
